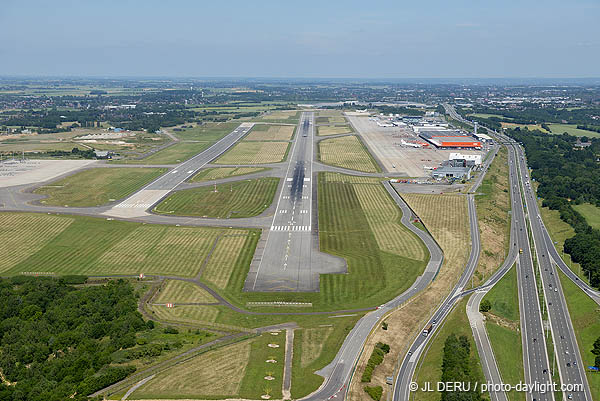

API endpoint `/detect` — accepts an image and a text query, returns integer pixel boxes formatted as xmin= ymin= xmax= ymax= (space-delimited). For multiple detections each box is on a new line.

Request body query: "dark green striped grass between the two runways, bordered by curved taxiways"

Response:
xmin=154 ymin=177 xmax=279 ymax=219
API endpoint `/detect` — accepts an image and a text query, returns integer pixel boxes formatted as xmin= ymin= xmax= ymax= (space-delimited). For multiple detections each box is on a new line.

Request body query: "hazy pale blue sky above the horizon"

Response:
xmin=0 ymin=0 xmax=600 ymax=79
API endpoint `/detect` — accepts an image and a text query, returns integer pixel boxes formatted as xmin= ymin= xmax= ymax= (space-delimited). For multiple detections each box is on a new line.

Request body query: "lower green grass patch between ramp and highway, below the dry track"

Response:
xmin=485 ymin=321 xmax=525 ymax=401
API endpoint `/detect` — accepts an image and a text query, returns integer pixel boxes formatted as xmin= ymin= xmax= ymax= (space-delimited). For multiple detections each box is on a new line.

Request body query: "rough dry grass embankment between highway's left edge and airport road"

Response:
xmin=473 ymin=147 xmax=510 ymax=286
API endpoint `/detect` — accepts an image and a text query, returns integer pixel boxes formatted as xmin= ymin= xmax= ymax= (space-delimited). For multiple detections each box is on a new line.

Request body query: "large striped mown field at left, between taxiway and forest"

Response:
xmin=0 ymin=213 xmax=253 ymax=277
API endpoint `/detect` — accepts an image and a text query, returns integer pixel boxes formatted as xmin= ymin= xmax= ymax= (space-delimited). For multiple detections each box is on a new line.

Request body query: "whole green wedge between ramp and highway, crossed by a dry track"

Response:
xmin=484 ymin=266 xmax=525 ymax=401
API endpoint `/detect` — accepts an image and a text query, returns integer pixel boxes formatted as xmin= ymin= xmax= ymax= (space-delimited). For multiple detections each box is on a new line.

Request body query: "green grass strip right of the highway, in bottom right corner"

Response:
xmin=558 ymin=271 xmax=600 ymax=401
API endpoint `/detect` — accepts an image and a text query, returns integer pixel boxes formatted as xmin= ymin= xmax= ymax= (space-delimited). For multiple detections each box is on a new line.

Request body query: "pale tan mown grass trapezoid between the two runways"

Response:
xmin=214 ymin=141 xmax=290 ymax=164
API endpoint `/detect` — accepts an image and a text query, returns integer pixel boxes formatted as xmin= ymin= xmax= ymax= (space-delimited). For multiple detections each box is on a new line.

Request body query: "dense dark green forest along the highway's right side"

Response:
xmin=507 ymin=128 xmax=600 ymax=288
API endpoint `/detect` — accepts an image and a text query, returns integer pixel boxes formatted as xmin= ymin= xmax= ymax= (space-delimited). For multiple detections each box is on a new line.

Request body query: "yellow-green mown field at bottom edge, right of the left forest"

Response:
xmin=129 ymin=340 xmax=252 ymax=400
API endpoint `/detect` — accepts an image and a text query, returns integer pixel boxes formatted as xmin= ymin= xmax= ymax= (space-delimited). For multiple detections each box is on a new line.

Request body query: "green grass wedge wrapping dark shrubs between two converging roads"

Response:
xmin=413 ymin=299 xmax=485 ymax=401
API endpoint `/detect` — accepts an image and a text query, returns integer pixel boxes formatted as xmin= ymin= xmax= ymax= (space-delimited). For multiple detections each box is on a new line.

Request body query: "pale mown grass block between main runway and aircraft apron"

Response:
xmin=319 ymin=135 xmax=380 ymax=173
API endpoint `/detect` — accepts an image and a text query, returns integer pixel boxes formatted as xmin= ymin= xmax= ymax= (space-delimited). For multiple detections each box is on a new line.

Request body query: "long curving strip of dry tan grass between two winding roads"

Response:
xmin=350 ymin=191 xmax=469 ymax=401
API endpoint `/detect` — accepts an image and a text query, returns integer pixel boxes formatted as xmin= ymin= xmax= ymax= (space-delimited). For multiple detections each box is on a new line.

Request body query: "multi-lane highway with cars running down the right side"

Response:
xmin=447 ymin=104 xmax=599 ymax=401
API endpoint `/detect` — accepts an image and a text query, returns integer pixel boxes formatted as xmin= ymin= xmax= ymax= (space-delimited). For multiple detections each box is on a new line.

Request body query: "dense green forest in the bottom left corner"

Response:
xmin=0 ymin=276 xmax=147 ymax=401
